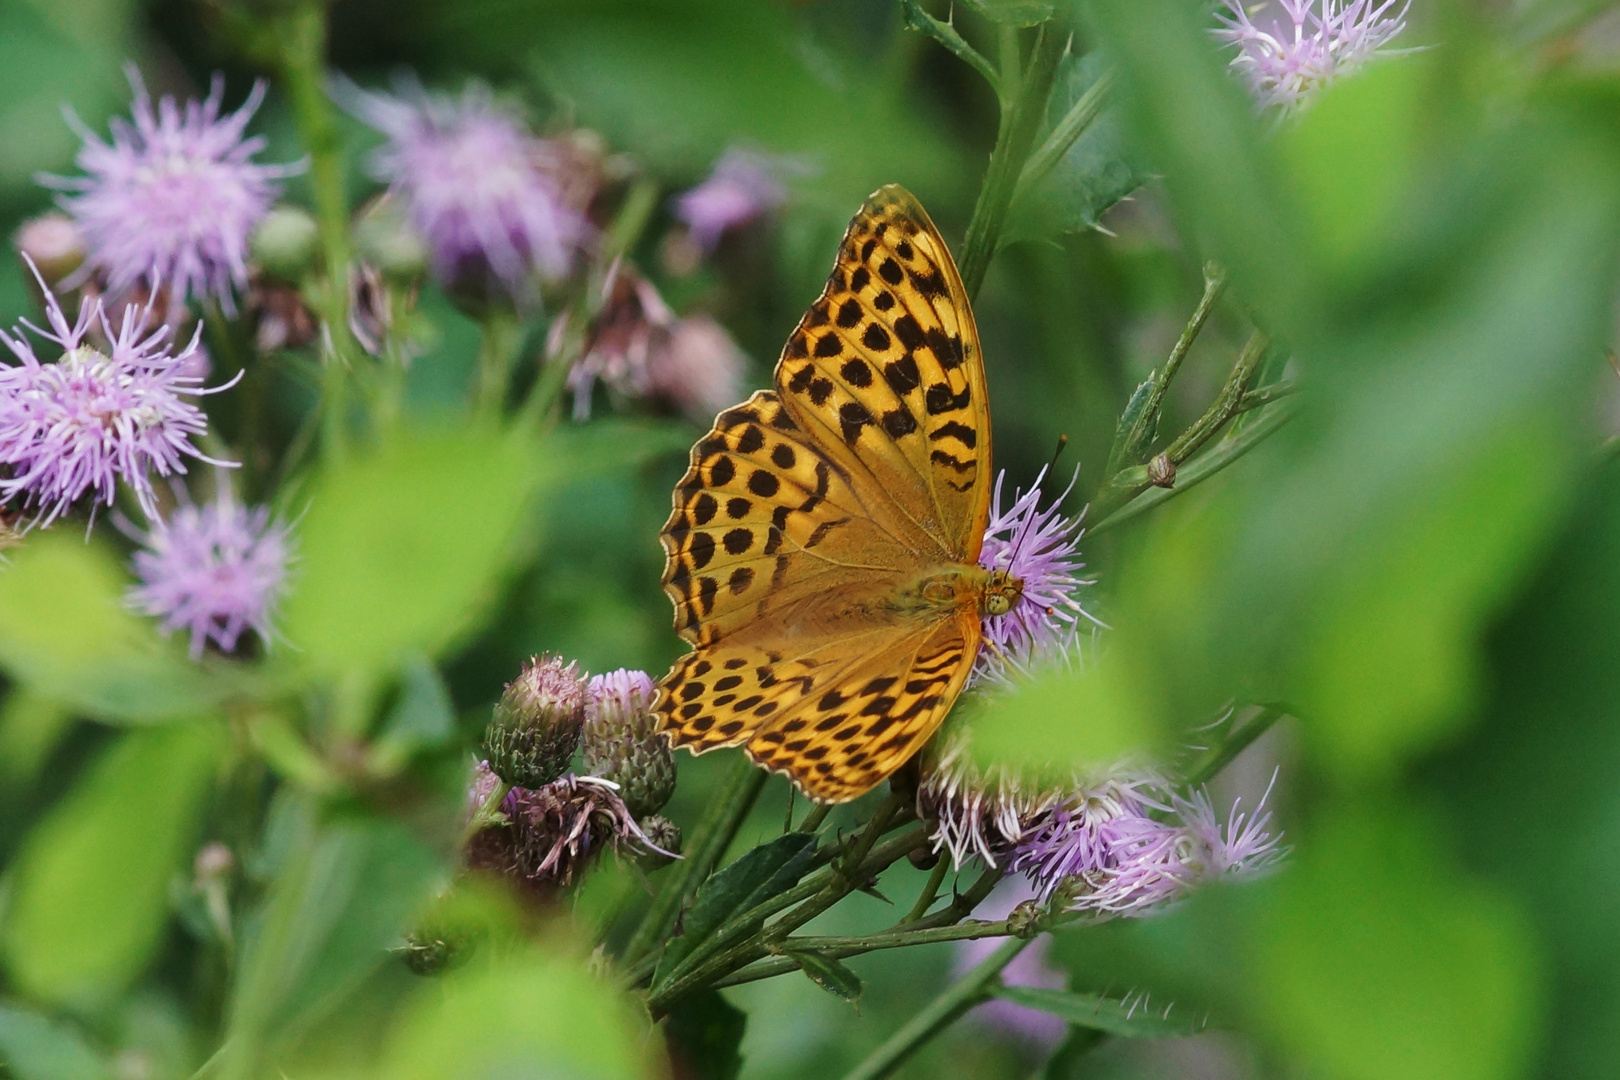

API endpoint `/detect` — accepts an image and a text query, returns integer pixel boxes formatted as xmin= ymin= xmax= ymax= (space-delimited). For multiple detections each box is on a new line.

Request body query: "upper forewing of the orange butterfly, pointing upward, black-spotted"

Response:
xmin=776 ymin=185 xmax=990 ymax=563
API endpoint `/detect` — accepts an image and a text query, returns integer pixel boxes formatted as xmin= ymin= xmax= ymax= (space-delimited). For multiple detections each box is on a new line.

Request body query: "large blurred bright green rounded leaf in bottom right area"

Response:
xmin=1251 ymin=803 xmax=1541 ymax=1080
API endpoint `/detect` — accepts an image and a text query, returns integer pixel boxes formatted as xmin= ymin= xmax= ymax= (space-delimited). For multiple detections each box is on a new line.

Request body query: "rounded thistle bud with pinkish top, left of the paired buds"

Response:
xmin=484 ymin=654 xmax=585 ymax=789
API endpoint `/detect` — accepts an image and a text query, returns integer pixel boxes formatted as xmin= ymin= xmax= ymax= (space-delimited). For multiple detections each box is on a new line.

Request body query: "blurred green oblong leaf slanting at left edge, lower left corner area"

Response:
xmin=0 ymin=724 xmax=224 ymax=1002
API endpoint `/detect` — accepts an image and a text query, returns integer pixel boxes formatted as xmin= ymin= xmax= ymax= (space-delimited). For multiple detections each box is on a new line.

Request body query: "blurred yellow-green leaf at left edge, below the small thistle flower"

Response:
xmin=0 ymin=529 xmax=230 ymax=722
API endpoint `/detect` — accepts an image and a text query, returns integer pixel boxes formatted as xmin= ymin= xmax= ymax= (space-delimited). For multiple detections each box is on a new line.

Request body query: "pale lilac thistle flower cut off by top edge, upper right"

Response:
xmin=1213 ymin=0 xmax=1411 ymax=108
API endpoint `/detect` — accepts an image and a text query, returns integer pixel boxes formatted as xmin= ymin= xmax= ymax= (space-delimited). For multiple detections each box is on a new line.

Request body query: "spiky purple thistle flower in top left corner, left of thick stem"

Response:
xmin=41 ymin=65 xmax=303 ymax=316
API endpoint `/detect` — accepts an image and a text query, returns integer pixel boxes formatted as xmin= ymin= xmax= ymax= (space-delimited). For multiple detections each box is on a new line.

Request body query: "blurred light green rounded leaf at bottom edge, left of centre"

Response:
xmin=374 ymin=944 xmax=659 ymax=1080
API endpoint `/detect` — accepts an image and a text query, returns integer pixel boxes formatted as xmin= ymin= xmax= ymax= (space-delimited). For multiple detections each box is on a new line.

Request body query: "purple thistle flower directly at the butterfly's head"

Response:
xmin=974 ymin=468 xmax=1095 ymax=682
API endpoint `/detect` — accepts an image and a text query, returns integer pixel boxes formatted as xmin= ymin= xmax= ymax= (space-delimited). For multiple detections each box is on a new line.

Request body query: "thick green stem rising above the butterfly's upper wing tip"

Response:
xmin=961 ymin=23 xmax=1068 ymax=298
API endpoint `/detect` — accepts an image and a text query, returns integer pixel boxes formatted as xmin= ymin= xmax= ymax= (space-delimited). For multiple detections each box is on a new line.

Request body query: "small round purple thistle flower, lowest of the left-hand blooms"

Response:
xmin=130 ymin=484 xmax=288 ymax=659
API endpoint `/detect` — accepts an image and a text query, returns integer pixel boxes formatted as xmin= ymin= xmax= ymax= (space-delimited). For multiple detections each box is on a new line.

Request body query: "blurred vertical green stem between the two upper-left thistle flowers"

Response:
xmin=275 ymin=0 xmax=355 ymax=460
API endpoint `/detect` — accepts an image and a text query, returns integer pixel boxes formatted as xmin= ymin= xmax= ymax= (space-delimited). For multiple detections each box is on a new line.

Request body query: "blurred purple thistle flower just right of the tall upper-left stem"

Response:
xmin=334 ymin=79 xmax=591 ymax=300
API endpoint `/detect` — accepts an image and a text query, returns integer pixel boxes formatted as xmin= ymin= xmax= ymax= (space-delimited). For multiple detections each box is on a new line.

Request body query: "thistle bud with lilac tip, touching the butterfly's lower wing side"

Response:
xmin=583 ymin=669 xmax=676 ymax=821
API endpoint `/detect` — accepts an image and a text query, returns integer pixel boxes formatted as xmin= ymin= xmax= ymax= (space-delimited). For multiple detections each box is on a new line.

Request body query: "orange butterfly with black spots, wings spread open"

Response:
xmin=653 ymin=185 xmax=1024 ymax=803
